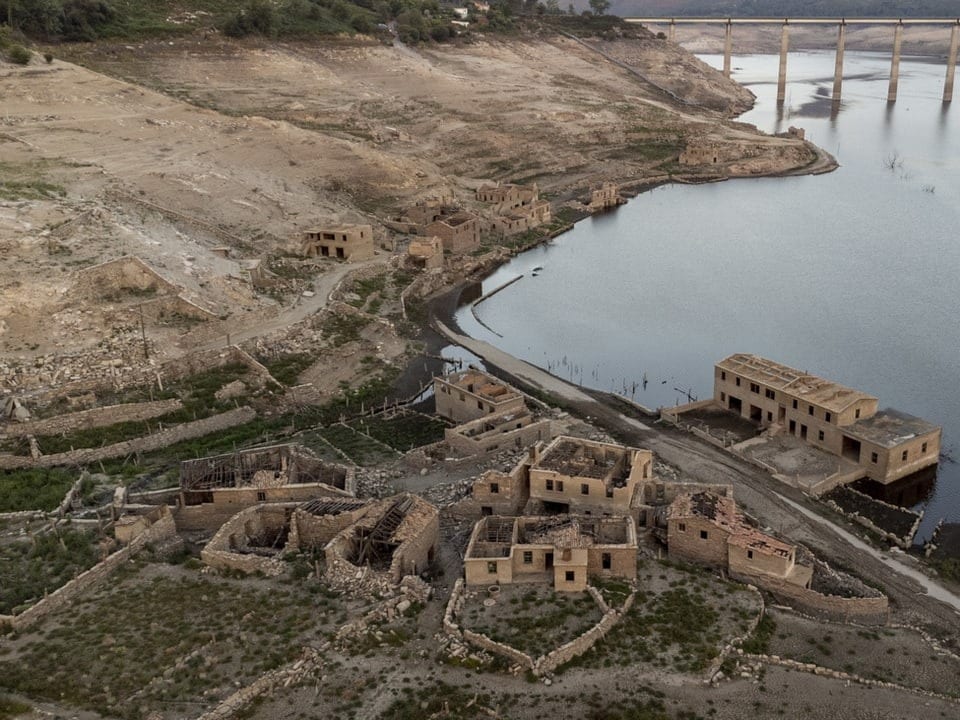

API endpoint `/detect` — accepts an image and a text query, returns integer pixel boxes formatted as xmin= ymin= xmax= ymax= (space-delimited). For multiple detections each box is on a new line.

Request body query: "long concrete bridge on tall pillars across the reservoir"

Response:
xmin=624 ymin=17 xmax=960 ymax=104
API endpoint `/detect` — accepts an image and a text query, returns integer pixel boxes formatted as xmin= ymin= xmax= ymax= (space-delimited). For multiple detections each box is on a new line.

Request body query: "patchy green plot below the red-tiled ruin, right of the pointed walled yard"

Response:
xmin=570 ymin=561 xmax=761 ymax=673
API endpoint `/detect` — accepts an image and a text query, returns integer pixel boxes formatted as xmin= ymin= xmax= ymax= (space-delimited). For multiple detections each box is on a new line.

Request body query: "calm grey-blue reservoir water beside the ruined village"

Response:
xmin=457 ymin=52 xmax=960 ymax=539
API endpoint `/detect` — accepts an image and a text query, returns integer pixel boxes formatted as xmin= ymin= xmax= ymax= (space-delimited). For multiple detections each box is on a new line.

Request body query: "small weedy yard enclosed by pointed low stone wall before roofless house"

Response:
xmin=461 ymin=584 xmax=603 ymax=657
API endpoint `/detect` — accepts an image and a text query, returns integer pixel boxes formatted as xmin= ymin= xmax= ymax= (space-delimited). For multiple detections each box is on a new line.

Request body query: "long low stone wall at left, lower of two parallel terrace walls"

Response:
xmin=0 ymin=407 xmax=257 ymax=470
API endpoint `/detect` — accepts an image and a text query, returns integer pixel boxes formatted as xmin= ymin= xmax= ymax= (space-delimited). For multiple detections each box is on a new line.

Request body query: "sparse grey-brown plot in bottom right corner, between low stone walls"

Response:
xmin=768 ymin=609 xmax=960 ymax=697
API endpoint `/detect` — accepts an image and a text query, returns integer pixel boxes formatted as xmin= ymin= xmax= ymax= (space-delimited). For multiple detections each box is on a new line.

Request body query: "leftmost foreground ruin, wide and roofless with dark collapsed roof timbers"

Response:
xmin=176 ymin=445 xmax=355 ymax=530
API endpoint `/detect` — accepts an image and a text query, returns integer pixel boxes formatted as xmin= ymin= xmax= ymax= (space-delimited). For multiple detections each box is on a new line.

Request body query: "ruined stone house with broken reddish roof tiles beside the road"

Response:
xmin=666 ymin=491 xmax=813 ymax=587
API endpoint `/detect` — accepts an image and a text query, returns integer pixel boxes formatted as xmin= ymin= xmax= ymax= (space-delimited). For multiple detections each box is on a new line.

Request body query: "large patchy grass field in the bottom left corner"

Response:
xmin=0 ymin=564 xmax=346 ymax=719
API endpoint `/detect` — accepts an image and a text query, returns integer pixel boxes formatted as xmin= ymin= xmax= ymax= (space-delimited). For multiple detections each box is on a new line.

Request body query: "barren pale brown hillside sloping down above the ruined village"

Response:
xmin=0 ymin=31 xmax=830 ymax=376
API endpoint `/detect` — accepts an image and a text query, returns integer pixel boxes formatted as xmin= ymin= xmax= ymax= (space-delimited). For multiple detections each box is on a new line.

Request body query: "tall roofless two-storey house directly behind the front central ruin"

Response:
xmin=528 ymin=435 xmax=653 ymax=519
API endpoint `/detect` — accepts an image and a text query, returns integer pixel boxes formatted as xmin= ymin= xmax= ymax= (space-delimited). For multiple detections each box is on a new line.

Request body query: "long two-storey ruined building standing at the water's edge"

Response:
xmin=713 ymin=353 xmax=941 ymax=484
